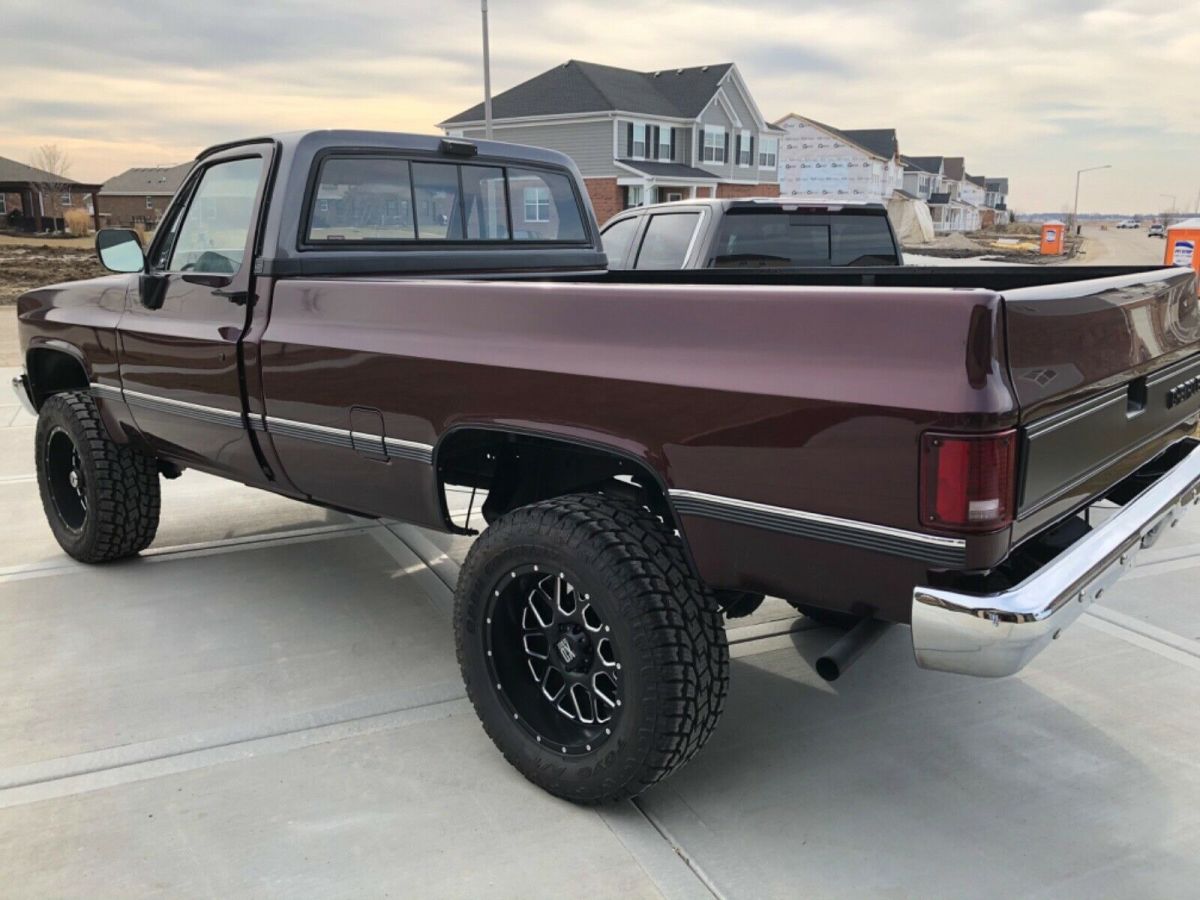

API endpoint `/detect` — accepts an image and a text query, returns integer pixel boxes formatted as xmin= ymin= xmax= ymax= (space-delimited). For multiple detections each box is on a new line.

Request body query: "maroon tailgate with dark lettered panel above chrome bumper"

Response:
xmin=1004 ymin=269 xmax=1200 ymax=540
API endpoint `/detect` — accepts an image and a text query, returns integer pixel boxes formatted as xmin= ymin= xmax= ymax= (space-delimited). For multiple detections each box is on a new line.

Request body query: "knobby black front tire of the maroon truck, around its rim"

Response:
xmin=35 ymin=392 xmax=160 ymax=563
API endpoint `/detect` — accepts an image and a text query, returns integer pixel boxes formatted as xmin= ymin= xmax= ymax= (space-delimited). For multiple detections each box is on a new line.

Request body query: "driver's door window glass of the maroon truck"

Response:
xmin=164 ymin=157 xmax=263 ymax=275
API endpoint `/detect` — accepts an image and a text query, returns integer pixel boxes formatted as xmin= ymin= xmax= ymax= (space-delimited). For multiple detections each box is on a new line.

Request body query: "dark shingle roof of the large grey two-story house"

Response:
xmin=440 ymin=59 xmax=733 ymax=125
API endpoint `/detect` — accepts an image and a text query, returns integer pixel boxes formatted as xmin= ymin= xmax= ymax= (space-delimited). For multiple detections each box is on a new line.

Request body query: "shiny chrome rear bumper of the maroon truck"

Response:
xmin=912 ymin=440 xmax=1200 ymax=678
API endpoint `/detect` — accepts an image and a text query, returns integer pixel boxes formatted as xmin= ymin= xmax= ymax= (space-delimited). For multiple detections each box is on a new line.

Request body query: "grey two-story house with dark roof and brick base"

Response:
xmin=438 ymin=60 xmax=781 ymax=222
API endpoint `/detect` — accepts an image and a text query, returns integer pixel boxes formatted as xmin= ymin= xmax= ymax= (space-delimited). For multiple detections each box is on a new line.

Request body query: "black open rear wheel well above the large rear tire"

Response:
xmin=434 ymin=428 xmax=678 ymax=532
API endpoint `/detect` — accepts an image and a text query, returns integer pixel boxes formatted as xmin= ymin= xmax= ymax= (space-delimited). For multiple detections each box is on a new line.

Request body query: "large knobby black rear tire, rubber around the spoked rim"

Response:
xmin=454 ymin=494 xmax=730 ymax=804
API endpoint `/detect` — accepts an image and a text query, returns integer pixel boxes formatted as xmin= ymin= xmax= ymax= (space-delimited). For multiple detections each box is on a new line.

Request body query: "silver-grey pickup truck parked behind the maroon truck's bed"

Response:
xmin=600 ymin=198 xmax=904 ymax=270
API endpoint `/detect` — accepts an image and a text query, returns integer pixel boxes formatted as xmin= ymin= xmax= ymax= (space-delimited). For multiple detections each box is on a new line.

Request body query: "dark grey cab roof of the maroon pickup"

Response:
xmin=196 ymin=128 xmax=575 ymax=169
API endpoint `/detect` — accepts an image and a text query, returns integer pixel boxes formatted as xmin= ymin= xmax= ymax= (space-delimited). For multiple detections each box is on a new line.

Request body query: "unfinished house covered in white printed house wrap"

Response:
xmin=775 ymin=113 xmax=904 ymax=203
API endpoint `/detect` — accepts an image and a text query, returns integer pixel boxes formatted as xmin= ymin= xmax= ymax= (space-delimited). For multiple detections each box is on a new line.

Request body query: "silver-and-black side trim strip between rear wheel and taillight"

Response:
xmin=668 ymin=490 xmax=967 ymax=568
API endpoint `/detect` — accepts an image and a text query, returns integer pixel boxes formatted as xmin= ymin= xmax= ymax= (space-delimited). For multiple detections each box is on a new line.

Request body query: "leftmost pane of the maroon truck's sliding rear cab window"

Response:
xmin=308 ymin=157 xmax=416 ymax=241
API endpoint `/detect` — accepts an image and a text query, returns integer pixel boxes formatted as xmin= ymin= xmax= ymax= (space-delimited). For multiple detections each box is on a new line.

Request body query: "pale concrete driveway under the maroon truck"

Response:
xmin=0 ymin=367 xmax=1200 ymax=898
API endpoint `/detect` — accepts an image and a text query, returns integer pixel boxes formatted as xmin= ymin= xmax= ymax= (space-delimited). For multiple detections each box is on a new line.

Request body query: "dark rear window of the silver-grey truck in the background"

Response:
xmin=708 ymin=208 xmax=900 ymax=269
